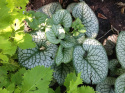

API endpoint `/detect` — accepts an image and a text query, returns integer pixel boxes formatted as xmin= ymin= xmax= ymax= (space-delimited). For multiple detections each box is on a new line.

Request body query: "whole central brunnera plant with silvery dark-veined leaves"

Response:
xmin=18 ymin=2 xmax=108 ymax=85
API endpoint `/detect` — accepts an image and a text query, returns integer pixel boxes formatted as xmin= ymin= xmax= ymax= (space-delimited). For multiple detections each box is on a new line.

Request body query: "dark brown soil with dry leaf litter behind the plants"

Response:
xmin=27 ymin=0 xmax=125 ymax=91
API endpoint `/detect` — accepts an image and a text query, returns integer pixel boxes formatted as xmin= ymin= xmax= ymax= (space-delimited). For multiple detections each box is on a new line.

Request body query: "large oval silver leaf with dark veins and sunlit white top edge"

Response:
xmin=73 ymin=38 xmax=108 ymax=84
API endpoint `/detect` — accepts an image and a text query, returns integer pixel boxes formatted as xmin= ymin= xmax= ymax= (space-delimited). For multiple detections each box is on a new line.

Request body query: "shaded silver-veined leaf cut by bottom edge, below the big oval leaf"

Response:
xmin=96 ymin=77 xmax=116 ymax=93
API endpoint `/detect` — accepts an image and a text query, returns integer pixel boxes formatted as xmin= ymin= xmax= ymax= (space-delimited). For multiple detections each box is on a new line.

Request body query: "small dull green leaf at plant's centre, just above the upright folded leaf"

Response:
xmin=60 ymin=35 xmax=76 ymax=48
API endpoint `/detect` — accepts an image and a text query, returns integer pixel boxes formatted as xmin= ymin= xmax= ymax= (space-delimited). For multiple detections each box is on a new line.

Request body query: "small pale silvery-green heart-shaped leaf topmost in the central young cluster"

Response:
xmin=52 ymin=9 xmax=72 ymax=28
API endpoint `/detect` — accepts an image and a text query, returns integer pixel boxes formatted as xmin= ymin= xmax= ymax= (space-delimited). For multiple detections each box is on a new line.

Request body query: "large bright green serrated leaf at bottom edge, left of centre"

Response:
xmin=22 ymin=66 xmax=53 ymax=93
